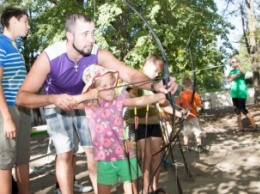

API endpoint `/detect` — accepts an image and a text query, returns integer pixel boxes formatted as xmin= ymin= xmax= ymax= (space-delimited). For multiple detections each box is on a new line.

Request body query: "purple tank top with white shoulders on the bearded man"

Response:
xmin=43 ymin=41 xmax=98 ymax=95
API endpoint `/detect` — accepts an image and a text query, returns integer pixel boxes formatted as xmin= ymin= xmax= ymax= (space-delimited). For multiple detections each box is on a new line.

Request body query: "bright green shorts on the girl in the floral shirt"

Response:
xmin=97 ymin=157 xmax=142 ymax=185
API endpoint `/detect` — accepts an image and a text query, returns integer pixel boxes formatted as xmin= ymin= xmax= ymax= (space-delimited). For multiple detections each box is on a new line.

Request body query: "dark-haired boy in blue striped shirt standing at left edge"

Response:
xmin=0 ymin=7 xmax=31 ymax=194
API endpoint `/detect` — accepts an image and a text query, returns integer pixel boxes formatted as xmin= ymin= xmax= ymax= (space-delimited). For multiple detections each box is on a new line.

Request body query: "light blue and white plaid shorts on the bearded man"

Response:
xmin=44 ymin=105 xmax=92 ymax=154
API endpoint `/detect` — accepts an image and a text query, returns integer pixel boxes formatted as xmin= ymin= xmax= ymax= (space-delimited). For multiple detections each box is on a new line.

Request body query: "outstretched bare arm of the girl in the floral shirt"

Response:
xmin=124 ymin=93 xmax=165 ymax=107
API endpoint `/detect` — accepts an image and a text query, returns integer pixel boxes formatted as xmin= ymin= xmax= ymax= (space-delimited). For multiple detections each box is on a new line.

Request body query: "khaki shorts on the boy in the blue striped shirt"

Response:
xmin=0 ymin=106 xmax=31 ymax=169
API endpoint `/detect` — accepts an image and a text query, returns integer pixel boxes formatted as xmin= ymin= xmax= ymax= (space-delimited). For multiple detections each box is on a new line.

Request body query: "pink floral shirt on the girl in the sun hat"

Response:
xmin=85 ymin=92 xmax=134 ymax=161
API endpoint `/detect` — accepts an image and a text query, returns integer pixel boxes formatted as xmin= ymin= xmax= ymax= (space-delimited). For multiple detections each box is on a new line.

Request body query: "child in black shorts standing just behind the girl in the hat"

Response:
xmin=126 ymin=55 xmax=167 ymax=193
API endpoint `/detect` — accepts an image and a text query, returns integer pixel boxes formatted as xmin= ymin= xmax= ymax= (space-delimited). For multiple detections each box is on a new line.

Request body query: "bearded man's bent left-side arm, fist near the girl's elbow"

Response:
xmin=16 ymin=52 xmax=74 ymax=110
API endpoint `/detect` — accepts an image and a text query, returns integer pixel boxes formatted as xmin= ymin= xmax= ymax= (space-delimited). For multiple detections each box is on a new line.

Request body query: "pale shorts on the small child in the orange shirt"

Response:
xmin=182 ymin=118 xmax=201 ymax=137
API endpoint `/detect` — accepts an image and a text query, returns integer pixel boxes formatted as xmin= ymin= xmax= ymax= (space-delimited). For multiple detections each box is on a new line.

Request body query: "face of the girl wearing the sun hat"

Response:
xmin=96 ymin=73 xmax=116 ymax=101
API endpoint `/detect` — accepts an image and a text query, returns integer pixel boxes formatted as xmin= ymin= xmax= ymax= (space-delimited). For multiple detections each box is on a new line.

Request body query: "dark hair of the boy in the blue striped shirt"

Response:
xmin=1 ymin=7 xmax=29 ymax=28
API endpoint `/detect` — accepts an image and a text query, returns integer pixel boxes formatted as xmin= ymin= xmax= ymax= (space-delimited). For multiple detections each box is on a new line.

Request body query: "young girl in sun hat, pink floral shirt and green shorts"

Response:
xmin=74 ymin=65 xmax=165 ymax=194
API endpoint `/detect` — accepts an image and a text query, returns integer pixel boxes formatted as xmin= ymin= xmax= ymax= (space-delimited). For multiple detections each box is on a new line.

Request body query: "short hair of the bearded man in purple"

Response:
xmin=65 ymin=13 xmax=92 ymax=33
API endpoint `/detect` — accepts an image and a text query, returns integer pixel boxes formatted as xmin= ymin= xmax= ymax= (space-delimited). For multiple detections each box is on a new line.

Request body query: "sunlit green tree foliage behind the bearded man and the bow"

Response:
xmin=0 ymin=0 xmax=235 ymax=89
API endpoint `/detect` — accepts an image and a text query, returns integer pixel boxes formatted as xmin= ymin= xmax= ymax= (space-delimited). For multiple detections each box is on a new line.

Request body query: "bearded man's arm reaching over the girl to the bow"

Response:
xmin=98 ymin=49 xmax=178 ymax=94
